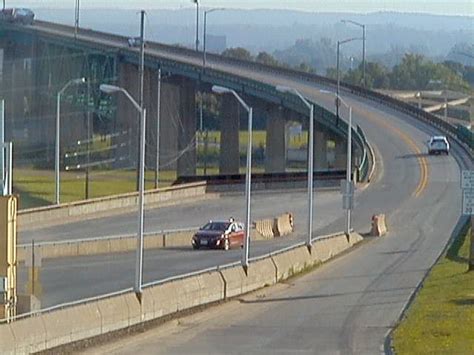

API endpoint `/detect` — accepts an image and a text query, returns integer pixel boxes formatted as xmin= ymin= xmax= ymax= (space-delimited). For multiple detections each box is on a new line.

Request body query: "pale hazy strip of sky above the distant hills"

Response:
xmin=6 ymin=0 xmax=474 ymax=16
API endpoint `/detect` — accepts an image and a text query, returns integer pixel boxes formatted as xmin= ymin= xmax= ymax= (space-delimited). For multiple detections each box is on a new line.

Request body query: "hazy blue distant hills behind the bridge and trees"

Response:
xmin=35 ymin=8 xmax=474 ymax=57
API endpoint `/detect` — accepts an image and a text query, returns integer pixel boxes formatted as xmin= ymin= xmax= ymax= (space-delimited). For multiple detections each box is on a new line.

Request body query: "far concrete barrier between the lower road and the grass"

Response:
xmin=18 ymin=182 xmax=207 ymax=229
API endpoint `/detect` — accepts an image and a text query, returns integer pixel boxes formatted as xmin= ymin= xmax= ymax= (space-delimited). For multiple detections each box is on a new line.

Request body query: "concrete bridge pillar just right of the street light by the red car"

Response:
xmin=265 ymin=106 xmax=288 ymax=173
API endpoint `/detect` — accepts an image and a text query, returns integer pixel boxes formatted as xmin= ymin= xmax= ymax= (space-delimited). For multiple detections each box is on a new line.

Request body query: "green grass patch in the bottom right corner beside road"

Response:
xmin=393 ymin=228 xmax=474 ymax=354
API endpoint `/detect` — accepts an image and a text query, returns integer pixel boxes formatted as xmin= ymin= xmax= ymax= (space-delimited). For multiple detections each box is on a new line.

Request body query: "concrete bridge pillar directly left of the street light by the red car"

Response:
xmin=219 ymin=95 xmax=241 ymax=174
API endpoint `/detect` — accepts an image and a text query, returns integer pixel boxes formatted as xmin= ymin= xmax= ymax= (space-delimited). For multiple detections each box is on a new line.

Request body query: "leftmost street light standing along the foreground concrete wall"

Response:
xmin=100 ymin=84 xmax=146 ymax=300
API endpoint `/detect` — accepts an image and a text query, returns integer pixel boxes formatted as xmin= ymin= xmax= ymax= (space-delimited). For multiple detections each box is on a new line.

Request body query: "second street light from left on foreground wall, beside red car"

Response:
xmin=212 ymin=85 xmax=253 ymax=271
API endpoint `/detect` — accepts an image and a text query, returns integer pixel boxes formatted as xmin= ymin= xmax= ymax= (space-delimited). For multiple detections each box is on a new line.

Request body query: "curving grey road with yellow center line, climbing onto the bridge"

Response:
xmin=17 ymin=23 xmax=472 ymax=354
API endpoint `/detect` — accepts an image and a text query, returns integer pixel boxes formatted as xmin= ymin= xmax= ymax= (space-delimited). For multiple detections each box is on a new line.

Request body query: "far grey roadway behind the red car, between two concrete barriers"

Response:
xmin=18 ymin=192 xmax=342 ymax=244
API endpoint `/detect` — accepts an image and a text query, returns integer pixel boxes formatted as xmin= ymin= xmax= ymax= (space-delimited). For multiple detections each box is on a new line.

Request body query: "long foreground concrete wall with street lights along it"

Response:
xmin=0 ymin=234 xmax=362 ymax=354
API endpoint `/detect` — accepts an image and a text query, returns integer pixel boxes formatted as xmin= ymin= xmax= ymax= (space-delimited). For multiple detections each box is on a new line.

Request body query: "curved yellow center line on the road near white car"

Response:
xmin=354 ymin=108 xmax=429 ymax=197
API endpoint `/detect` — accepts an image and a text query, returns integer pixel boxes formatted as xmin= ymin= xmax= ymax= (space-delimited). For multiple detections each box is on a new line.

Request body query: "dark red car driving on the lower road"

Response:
xmin=191 ymin=220 xmax=245 ymax=250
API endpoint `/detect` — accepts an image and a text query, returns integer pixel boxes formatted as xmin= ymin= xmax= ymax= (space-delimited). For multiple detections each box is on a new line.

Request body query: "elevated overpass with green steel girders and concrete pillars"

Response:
xmin=2 ymin=21 xmax=368 ymax=182
